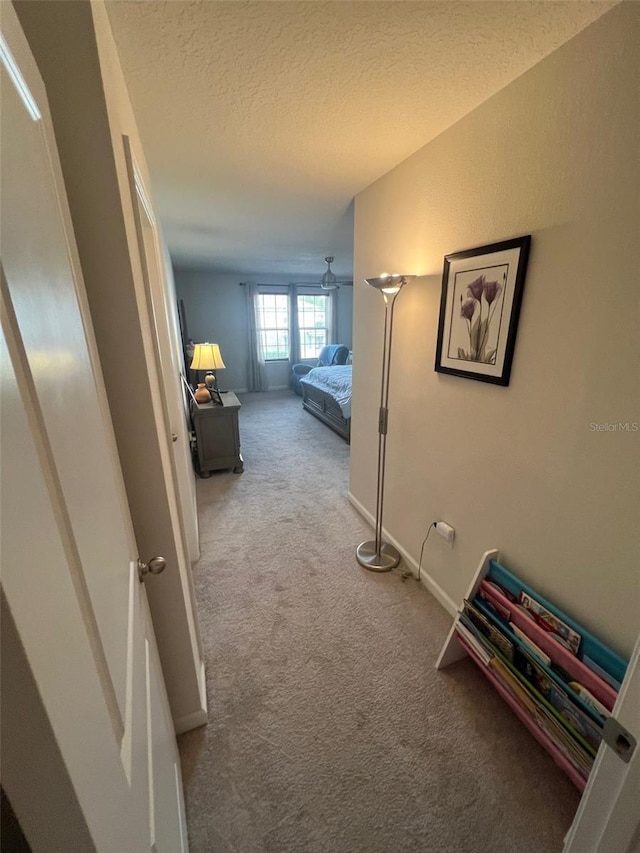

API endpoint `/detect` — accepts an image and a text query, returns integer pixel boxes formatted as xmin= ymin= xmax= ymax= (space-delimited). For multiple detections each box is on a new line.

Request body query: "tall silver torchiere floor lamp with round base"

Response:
xmin=356 ymin=273 xmax=415 ymax=572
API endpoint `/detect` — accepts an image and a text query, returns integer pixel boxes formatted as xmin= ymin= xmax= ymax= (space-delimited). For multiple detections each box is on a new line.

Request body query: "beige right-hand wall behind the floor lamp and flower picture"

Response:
xmin=351 ymin=3 xmax=640 ymax=654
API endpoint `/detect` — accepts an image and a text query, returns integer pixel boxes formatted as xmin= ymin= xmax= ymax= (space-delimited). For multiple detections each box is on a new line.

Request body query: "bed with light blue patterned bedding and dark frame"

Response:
xmin=300 ymin=364 xmax=351 ymax=444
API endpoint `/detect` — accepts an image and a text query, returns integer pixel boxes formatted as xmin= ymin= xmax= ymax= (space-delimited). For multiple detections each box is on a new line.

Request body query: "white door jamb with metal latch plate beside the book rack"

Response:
xmin=564 ymin=638 xmax=640 ymax=853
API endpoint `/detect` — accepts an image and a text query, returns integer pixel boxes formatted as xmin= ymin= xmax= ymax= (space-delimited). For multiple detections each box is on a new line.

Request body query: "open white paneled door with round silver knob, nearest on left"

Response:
xmin=0 ymin=4 xmax=187 ymax=853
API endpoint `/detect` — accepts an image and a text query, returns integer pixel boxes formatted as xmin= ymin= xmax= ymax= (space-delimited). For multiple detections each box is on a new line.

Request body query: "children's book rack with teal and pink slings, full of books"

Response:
xmin=436 ymin=550 xmax=627 ymax=791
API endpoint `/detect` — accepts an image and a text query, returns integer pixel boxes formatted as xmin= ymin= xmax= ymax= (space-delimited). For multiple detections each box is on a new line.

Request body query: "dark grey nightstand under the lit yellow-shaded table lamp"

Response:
xmin=191 ymin=391 xmax=244 ymax=477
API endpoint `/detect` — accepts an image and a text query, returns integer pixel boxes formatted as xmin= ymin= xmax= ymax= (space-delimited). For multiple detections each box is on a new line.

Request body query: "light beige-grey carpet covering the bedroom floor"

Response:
xmin=179 ymin=392 xmax=579 ymax=853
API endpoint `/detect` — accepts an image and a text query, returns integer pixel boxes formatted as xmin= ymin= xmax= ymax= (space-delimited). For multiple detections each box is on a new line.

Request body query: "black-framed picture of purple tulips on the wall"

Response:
xmin=435 ymin=235 xmax=531 ymax=385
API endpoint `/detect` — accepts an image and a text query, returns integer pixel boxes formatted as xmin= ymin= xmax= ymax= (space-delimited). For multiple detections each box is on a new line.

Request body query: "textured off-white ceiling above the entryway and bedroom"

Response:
xmin=107 ymin=0 xmax=615 ymax=277
